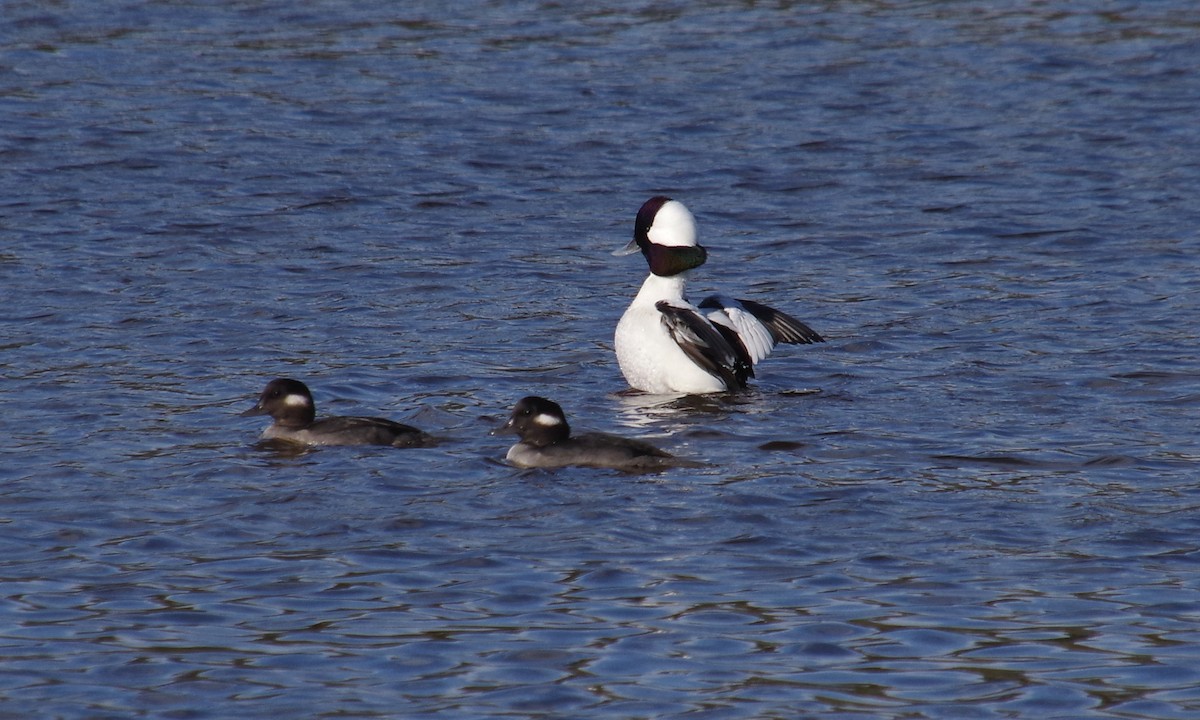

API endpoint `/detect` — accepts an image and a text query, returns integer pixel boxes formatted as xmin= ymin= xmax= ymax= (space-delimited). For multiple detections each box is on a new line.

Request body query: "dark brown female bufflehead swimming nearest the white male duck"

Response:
xmin=492 ymin=395 xmax=703 ymax=472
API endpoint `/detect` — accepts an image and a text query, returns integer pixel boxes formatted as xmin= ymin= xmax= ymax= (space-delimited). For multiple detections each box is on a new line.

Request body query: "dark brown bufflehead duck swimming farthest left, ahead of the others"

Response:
xmin=241 ymin=378 xmax=433 ymax=448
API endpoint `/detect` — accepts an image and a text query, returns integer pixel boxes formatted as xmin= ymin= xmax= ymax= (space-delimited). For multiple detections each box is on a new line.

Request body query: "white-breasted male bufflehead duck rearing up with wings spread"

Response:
xmin=613 ymin=196 xmax=824 ymax=394
